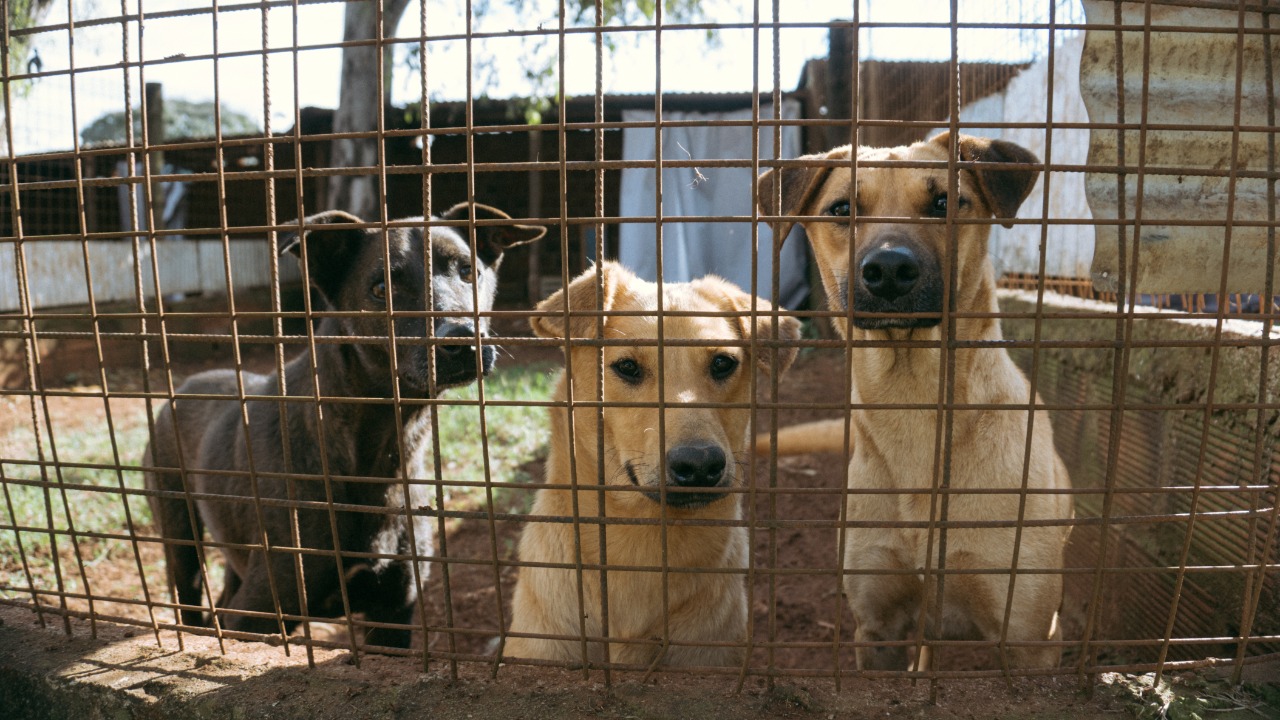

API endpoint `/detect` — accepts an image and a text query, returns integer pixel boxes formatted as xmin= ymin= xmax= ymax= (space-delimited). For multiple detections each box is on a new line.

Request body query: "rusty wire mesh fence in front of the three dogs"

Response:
xmin=0 ymin=0 xmax=1280 ymax=684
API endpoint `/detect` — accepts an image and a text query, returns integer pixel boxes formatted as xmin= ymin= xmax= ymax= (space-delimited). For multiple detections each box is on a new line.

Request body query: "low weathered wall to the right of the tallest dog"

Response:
xmin=1001 ymin=291 xmax=1280 ymax=659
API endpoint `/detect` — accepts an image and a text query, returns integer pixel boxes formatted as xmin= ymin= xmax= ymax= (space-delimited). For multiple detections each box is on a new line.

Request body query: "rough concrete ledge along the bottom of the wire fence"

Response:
xmin=0 ymin=607 xmax=1280 ymax=720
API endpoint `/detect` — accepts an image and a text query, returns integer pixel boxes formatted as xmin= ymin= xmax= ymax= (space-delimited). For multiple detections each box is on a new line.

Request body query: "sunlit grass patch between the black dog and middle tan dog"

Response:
xmin=439 ymin=363 xmax=557 ymax=509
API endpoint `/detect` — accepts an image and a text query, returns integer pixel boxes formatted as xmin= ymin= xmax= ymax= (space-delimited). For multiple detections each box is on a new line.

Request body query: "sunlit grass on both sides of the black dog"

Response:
xmin=0 ymin=364 xmax=556 ymax=597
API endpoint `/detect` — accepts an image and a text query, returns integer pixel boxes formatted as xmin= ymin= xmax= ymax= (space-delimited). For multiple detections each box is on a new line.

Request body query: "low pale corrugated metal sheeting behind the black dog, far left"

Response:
xmin=0 ymin=240 xmax=300 ymax=313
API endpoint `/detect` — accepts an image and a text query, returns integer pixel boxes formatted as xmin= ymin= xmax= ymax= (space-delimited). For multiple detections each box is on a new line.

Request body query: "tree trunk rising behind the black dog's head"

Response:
xmin=323 ymin=0 xmax=408 ymax=220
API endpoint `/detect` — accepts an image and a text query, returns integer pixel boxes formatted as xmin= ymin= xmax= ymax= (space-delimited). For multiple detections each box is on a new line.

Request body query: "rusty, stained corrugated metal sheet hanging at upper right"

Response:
xmin=1080 ymin=0 xmax=1280 ymax=293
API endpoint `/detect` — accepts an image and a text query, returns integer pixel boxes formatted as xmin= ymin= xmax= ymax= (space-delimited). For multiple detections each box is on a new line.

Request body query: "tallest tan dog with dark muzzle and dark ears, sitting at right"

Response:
xmin=756 ymin=133 xmax=1073 ymax=669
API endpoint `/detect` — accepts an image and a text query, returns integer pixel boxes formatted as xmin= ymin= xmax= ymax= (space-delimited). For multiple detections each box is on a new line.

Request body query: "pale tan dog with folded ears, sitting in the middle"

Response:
xmin=504 ymin=263 xmax=800 ymax=666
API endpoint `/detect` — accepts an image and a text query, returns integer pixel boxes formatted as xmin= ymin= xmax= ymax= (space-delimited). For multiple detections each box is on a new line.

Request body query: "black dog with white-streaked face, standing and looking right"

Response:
xmin=143 ymin=204 xmax=545 ymax=647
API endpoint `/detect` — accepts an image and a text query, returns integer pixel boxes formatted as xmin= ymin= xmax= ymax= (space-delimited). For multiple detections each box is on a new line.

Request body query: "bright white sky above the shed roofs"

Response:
xmin=0 ymin=0 xmax=1078 ymax=155
